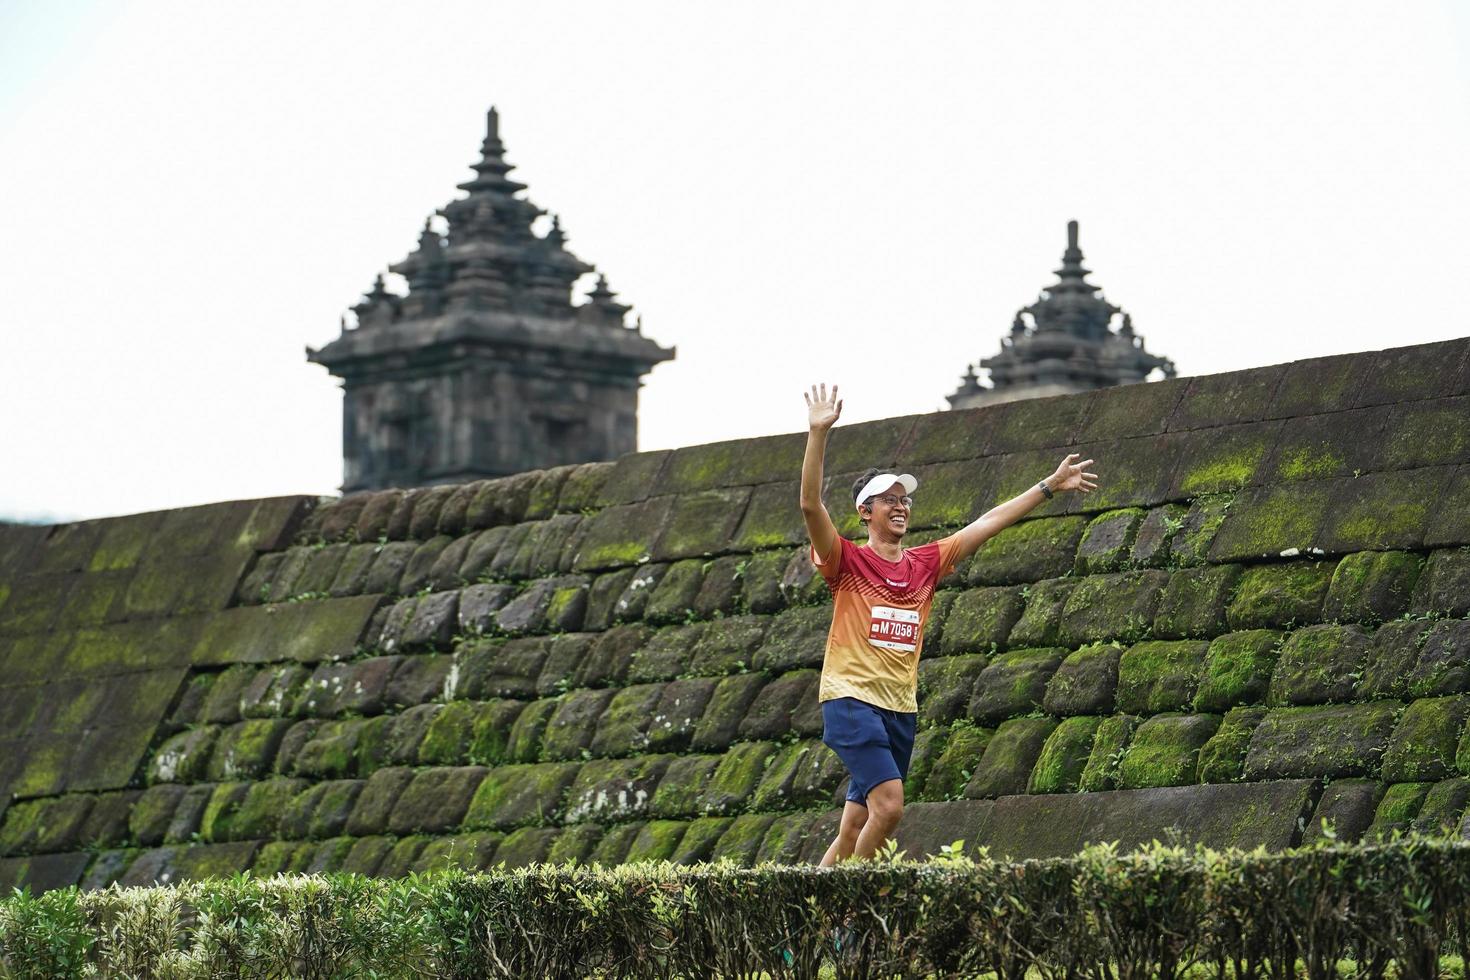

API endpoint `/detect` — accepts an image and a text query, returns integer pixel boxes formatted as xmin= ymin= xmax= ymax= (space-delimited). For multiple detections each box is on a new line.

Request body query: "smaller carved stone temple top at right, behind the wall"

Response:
xmin=948 ymin=222 xmax=1175 ymax=408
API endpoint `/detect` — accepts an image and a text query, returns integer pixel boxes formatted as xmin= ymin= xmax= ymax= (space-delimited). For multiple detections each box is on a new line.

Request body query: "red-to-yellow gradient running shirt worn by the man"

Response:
xmin=811 ymin=536 xmax=960 ymax=711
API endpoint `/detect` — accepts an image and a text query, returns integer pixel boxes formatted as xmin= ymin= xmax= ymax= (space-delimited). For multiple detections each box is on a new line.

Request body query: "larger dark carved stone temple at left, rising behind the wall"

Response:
xmin=307 ymin=109 xmax=675 ymax=492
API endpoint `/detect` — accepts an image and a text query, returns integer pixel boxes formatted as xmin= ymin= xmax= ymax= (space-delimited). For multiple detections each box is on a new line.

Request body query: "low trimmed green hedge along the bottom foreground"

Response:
xmin=0 ymin=837 xmax=1470 ymax=980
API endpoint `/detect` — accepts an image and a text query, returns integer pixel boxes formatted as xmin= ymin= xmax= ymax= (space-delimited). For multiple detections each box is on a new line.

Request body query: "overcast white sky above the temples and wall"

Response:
xmin=0 ymin=0 xmax=1470 ymax=517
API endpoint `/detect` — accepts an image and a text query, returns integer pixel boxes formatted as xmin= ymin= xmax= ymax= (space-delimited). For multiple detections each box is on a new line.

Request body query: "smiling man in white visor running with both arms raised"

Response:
xmin=801 ymin=385 xmax=1097 ymax=865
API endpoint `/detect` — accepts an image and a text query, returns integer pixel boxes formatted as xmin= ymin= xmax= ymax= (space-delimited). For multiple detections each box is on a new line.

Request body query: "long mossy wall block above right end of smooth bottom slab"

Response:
xmin=1245 ymin=701 xmax=1402 ymax=780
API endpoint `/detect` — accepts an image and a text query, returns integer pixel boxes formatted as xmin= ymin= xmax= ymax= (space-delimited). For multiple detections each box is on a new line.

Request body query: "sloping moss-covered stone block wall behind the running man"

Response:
xmin=0 ymin=341 xmax=1470 ymax=887
